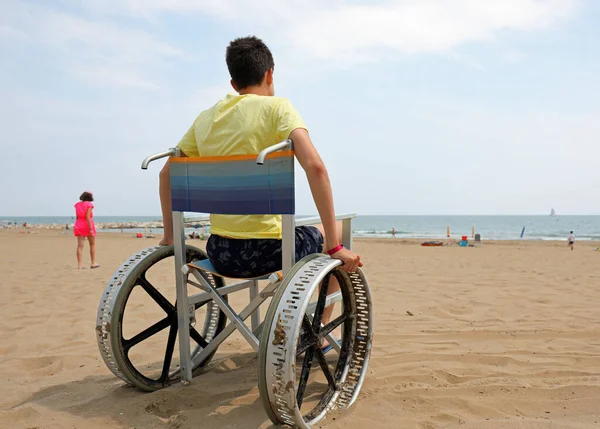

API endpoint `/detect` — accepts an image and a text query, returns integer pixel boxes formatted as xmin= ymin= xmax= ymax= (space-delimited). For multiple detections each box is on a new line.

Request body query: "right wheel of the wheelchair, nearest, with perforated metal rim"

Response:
xmin=258 ymin=255 xmax=373 ymax=428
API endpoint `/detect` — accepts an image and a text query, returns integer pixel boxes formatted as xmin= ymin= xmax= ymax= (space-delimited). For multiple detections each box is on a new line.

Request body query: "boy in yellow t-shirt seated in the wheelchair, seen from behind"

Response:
xmin=159 ymin=37 xmax=362 ymax=338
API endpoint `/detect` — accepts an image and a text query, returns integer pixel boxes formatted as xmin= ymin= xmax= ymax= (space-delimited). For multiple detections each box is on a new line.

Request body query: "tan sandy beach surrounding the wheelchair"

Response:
xmin=0 ymin=230 xmax=600 ymax=429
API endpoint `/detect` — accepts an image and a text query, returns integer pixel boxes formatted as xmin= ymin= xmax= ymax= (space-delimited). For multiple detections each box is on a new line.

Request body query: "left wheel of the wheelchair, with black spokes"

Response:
xmin=96 ymin=246 xmax=227 ymax=391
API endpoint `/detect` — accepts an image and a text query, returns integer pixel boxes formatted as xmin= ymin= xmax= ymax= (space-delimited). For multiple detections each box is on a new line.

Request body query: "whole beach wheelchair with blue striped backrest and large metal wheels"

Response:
xmin=96 ymin=140 xmax=373 ymax=428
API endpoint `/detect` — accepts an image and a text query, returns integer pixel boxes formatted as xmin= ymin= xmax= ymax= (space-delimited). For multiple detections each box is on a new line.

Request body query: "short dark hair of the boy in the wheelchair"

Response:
xmin=225 ymin=36 xmax=275 ymax=90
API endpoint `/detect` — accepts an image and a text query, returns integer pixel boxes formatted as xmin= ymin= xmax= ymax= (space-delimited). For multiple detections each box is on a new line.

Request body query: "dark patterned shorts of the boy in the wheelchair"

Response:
xmin=206 ymin=226 xmax=323 ymax=278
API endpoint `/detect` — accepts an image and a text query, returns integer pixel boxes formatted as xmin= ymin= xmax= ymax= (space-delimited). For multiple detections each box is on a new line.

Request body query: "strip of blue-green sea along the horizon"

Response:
xmin=0 ymin=215 xmax=600 ymax=240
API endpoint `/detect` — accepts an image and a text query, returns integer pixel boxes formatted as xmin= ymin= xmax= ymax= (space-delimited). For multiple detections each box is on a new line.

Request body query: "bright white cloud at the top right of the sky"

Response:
xmin=284 ymin=0 xmax=575 ymax=61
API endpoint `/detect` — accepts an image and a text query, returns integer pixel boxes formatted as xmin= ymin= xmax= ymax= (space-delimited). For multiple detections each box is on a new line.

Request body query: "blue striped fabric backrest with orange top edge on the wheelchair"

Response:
xmin=170 ymin=150 xmax=295 ymax=214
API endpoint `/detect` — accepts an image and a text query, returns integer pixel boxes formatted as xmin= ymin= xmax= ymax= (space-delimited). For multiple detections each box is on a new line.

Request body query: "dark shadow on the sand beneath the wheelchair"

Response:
xmin=15 ymin=353 xmax=276 ymax=429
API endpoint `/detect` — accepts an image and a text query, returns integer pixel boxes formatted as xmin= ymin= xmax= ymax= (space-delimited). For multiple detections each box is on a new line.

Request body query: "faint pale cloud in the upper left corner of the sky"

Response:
xmin=0 ymin=2 xmax=185 ymax=89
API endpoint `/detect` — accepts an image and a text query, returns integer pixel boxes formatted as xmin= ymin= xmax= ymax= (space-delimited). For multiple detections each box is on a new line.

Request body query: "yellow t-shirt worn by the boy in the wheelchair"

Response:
xmin=177 ymin=94 xmax=306 ymax=239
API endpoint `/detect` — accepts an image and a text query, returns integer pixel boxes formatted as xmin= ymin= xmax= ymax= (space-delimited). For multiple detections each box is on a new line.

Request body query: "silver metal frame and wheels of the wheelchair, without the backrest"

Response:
xmin=96 ymin=140 xmax=373 ymax=428
